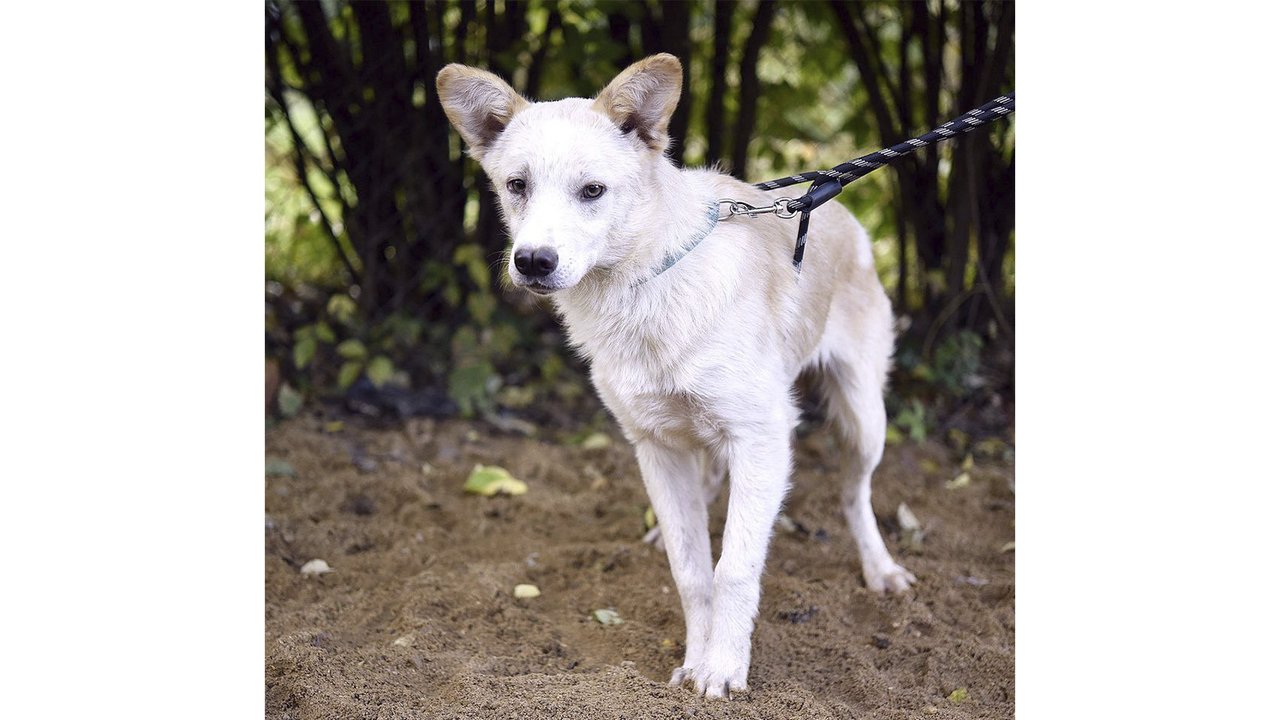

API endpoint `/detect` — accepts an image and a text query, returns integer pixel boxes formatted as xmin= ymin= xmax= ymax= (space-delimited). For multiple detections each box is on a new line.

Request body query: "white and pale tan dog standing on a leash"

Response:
xmin=436 ymin=54 xmax=915 ymax=698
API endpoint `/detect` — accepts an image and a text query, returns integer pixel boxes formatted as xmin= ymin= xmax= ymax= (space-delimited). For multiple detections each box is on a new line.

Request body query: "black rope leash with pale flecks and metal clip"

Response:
xmin=727 ymin=92 xmax=1014 ymax=266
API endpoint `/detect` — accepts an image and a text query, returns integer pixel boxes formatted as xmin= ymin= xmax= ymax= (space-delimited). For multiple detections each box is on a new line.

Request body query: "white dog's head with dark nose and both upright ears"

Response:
xmin=435 ymin=54 xmax=682 ymax=295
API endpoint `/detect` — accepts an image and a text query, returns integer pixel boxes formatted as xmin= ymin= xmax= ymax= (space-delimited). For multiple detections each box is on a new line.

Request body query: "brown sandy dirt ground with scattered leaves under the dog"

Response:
xmin=265 ymin=416 xmax=1014 ymax=720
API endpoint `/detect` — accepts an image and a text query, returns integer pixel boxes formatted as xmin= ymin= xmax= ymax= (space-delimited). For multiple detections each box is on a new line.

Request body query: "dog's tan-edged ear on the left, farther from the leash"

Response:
xmin=435 ymin=63 xmax=529 ymax=160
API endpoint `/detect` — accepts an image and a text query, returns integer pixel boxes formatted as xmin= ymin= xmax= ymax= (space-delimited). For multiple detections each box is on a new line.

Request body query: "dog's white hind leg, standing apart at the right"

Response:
xmin=822 ymin=357 xmax=915 ymax=593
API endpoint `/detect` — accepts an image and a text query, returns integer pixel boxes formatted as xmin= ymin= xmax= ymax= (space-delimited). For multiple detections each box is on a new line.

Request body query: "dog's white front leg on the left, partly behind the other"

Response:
xmin=636 ymin=441 xmax=712 ymax=685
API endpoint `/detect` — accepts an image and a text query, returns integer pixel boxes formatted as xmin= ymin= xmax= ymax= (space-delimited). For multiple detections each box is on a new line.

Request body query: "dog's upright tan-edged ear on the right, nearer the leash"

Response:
xmin=593 ymin=53 xmax=684 ymax=152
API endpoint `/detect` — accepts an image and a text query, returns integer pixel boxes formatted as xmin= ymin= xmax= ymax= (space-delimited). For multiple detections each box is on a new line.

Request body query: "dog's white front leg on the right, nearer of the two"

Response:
xmin=694 ymin=423 xmax=791 ymax=698
